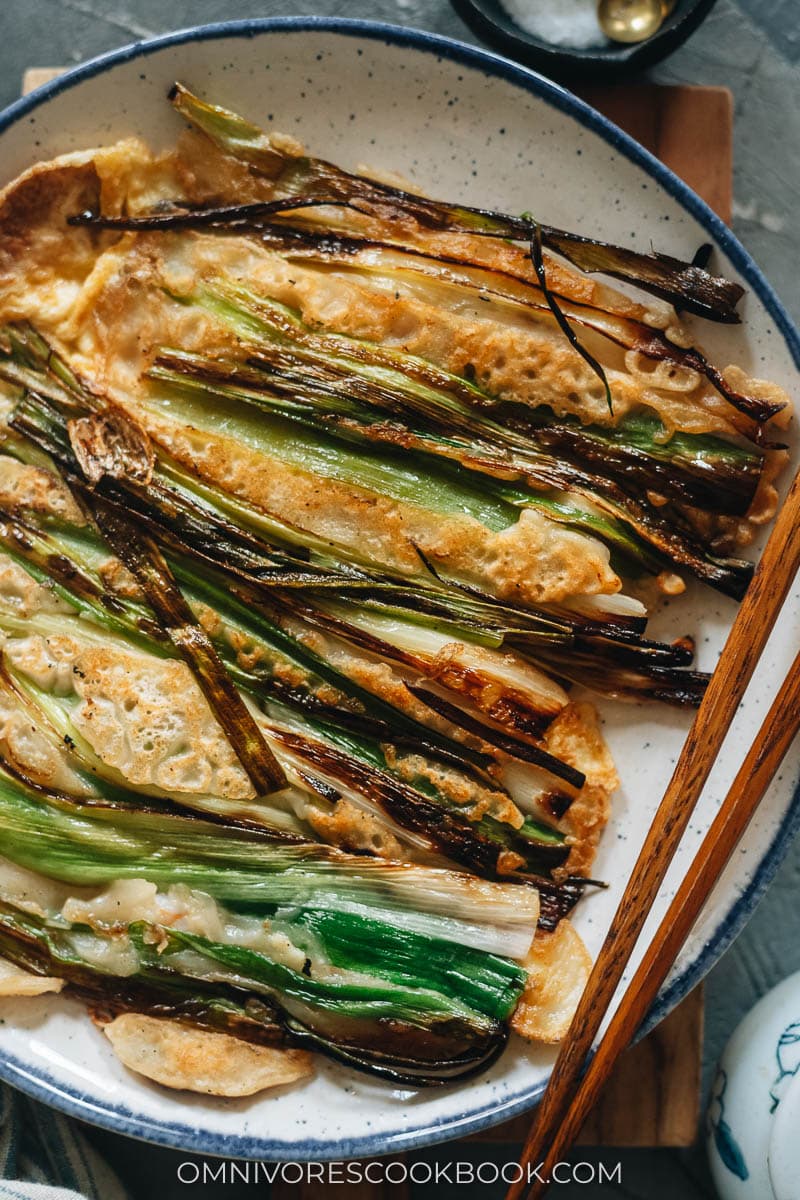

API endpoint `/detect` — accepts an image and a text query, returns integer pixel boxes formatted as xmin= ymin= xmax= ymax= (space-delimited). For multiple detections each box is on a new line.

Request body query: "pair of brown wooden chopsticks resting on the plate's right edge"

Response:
xmin=506 ymin=472 xmax=800 ymax=1200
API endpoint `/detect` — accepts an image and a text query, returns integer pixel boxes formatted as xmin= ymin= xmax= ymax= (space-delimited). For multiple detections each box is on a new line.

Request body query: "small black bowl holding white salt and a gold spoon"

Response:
xmin=451 ymin=0 xmax=716 ymax=84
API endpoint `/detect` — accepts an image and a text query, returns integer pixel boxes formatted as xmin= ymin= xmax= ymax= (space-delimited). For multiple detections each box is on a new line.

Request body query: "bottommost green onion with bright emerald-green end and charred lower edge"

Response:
xmin=0 ymin=888 xmax=524 ymax=1085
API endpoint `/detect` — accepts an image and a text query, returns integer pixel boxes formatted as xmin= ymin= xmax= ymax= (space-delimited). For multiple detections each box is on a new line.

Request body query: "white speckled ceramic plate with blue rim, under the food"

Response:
xmin=0 ymin=18 xmax=800 ymax=1159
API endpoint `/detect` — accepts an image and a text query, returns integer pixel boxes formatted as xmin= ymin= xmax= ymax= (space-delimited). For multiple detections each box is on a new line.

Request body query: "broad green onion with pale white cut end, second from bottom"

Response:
xmin=0 ymin=769 xmax=539 ymax=959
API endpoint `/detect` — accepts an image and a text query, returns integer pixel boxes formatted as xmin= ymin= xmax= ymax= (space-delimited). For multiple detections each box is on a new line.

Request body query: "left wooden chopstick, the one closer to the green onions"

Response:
xmin=506 ymin=473 xmax=800 ymax=1200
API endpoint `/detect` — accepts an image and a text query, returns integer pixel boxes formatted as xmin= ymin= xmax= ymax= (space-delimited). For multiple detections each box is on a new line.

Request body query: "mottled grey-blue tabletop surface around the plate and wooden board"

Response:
xmin=0 ymin=0 xmax=800 ymax=1200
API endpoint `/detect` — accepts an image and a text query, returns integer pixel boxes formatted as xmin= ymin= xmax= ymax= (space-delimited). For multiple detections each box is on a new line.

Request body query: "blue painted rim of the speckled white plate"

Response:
xmin=0 ymin=17 xmax=800 ymax=1162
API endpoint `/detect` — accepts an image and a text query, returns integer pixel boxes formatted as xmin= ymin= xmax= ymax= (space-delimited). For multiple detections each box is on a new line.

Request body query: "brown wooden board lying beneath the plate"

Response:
xmin=23 ymin=67 xmax=733 ymax=1171
